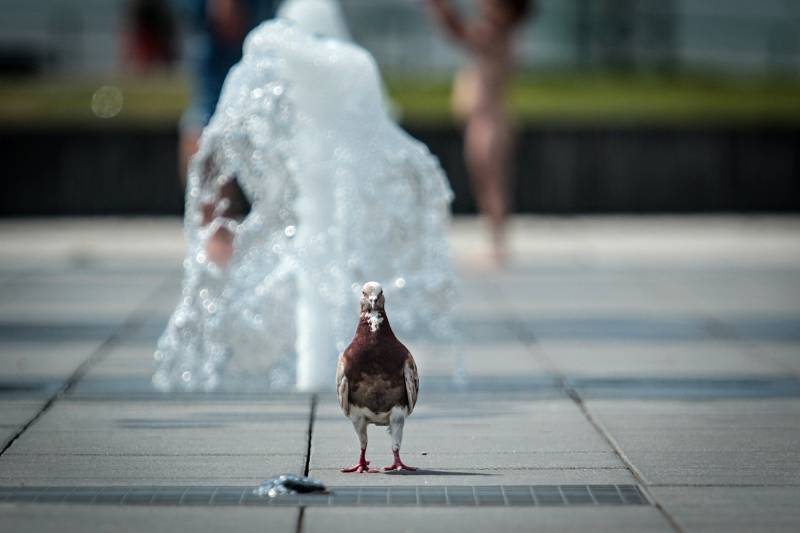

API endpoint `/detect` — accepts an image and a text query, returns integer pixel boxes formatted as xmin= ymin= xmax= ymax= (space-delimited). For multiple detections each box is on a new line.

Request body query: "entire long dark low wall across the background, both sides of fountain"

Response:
xmin=0 ymin=125 xmax=800 ymax=216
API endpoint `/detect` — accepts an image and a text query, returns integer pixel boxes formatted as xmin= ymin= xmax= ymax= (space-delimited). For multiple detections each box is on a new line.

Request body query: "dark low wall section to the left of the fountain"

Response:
xmin=0 ymin=128 xmax=183 ymax=216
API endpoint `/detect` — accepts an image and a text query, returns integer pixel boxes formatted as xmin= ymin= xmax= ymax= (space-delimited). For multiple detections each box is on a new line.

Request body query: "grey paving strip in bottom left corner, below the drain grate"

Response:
xmin=0 ymin=504 xmax=298 ymax=533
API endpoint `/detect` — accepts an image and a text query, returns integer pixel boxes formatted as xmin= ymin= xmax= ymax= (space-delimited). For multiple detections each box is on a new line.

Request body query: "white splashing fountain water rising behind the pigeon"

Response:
xmin=153 ymin=0 xmax=454 ymax=390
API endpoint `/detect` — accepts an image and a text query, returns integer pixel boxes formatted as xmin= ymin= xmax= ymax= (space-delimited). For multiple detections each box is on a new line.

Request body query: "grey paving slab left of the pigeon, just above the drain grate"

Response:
xmin=0 ymin=401 xmax=310 ymax=486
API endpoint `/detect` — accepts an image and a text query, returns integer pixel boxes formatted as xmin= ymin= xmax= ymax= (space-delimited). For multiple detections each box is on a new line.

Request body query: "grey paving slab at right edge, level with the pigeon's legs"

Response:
xmin=588 ymin=399 xmax=800 ymax=485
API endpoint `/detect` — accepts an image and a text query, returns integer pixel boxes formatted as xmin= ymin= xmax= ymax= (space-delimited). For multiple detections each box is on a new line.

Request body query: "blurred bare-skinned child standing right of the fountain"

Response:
xmin=428 ymin=0 xmax=533 ymax=266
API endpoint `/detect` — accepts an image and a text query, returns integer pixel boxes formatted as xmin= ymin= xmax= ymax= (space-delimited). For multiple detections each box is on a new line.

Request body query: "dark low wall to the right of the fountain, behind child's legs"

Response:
xmin=412 ymin=126 xmax=800 ymax=213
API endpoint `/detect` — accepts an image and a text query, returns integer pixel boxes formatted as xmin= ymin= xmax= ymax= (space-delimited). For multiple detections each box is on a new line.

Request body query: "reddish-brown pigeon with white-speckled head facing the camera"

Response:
xmin=336 ymin=281 xmax=419 ymax=473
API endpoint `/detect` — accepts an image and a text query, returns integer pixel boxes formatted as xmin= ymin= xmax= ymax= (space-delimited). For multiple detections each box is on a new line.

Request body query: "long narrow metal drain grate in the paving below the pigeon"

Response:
xmin=0 ymin=485 xmax=649 ymax=507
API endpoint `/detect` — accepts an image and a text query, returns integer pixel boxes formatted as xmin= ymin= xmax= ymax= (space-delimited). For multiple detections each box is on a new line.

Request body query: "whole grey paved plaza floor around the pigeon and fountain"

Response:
xmin=0 ymin=216 xmax=800 ymax=533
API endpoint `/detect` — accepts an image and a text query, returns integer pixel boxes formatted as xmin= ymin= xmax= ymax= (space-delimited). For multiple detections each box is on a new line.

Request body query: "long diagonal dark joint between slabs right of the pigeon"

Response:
xmin=506 ymin=312 xmax=685 ymax=533
